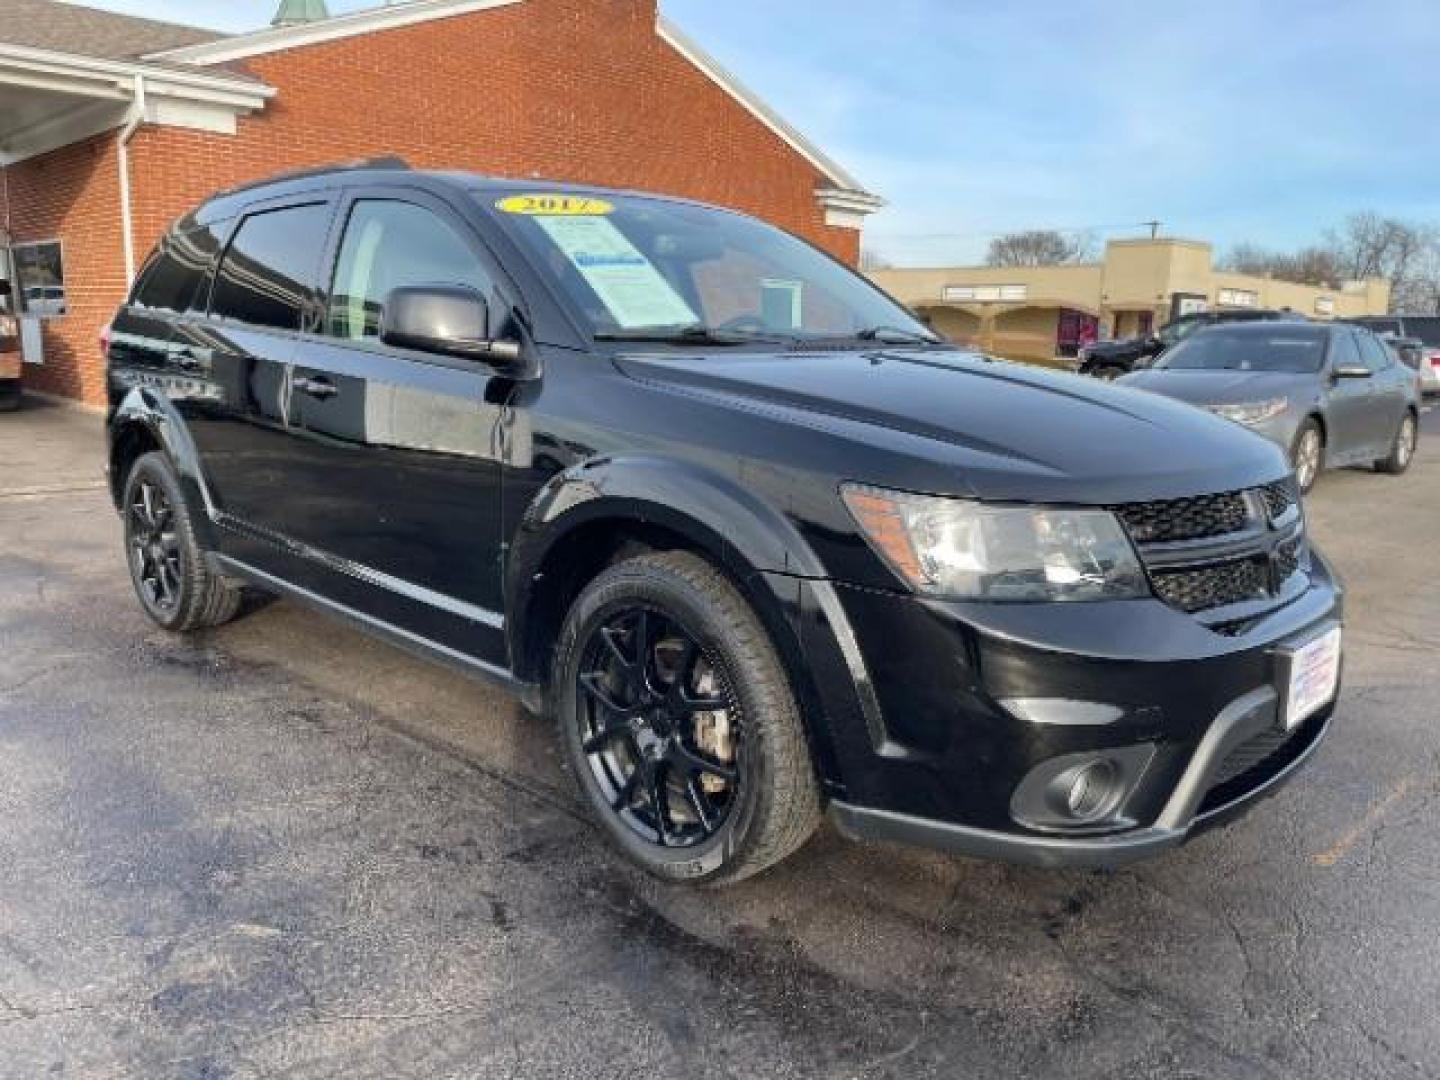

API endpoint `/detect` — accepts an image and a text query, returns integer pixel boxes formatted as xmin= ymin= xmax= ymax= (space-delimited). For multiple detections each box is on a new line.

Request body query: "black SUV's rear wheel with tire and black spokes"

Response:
xmin=122 ymin=454 xmax=242 ymax=634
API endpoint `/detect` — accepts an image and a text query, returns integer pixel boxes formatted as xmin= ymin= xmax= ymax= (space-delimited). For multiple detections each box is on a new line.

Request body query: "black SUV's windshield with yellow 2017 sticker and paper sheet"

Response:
xmin=481 ymin=192 xmax=939 ymax=344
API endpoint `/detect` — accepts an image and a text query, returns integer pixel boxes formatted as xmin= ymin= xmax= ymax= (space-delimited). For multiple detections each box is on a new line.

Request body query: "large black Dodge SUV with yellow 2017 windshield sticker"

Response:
xmin=107 ymin=167 xmax=1341 ymax=880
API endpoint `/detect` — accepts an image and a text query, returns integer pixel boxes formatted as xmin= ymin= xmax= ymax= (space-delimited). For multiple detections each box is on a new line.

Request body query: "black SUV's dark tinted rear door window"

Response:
xmin=210 ymin=203 xmax=330 ymax=330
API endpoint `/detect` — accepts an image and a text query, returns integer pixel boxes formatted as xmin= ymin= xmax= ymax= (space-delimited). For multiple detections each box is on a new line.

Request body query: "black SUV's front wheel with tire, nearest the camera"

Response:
xmin=552 ymin=552 xmax=819 ymax=883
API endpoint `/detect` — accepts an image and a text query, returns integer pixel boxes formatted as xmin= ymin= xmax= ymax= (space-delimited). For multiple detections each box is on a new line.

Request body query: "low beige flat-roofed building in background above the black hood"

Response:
xmin=870 ymin=239 xmax=1390 ymax=363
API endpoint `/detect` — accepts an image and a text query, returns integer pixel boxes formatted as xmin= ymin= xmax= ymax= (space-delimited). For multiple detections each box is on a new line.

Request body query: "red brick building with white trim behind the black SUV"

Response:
xmin=0 ymin=0 xmax=880 ymax=402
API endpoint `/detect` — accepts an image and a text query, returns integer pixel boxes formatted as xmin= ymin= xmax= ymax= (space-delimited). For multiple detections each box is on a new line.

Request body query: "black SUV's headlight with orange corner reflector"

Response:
xmin=841 ymin=484 xmax=1149 ymax=600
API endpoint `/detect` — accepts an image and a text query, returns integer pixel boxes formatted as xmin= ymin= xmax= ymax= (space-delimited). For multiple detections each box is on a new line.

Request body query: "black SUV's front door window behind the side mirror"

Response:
xmin=328 ymin=200 xmax=490 ymax=341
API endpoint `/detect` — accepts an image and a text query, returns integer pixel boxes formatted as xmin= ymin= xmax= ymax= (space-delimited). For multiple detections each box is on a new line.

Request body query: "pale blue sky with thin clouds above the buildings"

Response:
xmin=87 ymin=0 xmax=1440 ymax=265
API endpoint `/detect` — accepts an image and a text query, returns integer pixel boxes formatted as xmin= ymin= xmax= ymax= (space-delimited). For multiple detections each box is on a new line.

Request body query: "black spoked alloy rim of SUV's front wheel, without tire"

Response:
xmin=576 ymin=606 xmax=744 ymax=848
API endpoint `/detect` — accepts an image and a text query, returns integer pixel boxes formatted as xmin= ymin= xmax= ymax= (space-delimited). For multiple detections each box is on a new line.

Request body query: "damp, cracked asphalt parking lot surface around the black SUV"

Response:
xmin=0 ymin=400 xmax=1440 ymax=1077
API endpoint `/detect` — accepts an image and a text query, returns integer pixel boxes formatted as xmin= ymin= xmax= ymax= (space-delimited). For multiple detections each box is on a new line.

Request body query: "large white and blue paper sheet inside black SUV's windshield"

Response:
xmin=536 ymin=216 xmax=700 ymax=330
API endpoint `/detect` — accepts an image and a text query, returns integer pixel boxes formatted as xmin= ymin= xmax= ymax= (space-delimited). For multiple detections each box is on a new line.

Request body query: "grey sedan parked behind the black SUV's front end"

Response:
xmin=1122 ymin=323 xmax=1420 ymax=491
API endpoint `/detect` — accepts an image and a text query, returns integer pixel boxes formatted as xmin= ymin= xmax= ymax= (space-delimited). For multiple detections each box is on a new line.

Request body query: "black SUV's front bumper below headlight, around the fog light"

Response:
xmin=804 ymin=556 xmax=1342 ymax=867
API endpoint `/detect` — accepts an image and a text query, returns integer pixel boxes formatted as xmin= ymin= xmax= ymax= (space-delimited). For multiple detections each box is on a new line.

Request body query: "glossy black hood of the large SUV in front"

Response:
xmin=616 ymin=348 xmax=1287 ymax=504
